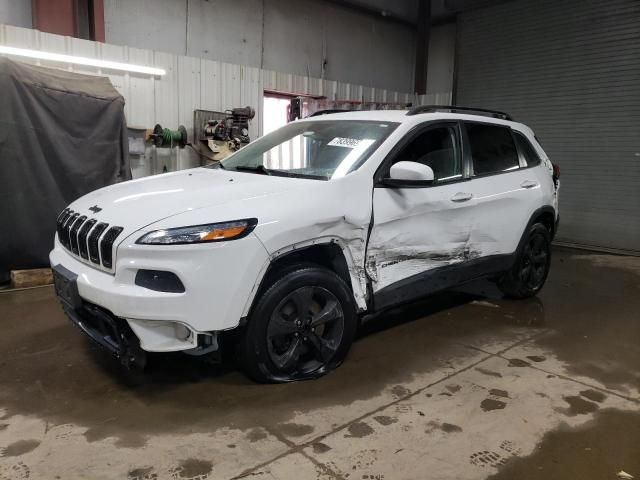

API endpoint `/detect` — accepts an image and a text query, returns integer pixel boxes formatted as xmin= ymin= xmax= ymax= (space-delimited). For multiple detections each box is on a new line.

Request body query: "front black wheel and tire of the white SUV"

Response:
xmin=238 ymin=265 xmax=358 ymax=383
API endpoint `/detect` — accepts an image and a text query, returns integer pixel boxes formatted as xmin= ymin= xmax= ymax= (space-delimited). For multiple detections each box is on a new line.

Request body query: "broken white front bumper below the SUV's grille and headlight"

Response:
xmin=49 ymin=235 xmax=268 ymax=356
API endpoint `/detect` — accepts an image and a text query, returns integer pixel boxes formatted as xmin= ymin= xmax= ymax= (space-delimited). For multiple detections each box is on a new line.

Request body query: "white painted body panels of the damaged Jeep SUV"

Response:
xmin=50 ymin=111 xmax=553 ymax=350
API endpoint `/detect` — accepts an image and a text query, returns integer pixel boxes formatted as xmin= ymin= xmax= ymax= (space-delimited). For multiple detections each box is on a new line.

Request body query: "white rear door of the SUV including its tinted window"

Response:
xmin=464 ymin=122 xmax=543 ymax=257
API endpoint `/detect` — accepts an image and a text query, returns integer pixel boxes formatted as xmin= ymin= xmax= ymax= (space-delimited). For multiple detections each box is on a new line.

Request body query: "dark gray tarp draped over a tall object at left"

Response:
xmin=0 ymin=58 xmax=131 ymax=281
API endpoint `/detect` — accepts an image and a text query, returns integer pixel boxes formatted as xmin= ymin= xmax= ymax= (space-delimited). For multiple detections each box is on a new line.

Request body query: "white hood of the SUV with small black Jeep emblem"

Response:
xmin=69 ymin=168 xmax=308 ymax=237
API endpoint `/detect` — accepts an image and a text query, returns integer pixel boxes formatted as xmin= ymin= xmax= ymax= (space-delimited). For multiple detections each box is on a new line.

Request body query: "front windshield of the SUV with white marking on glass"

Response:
xmin=222 ymin=120 xmax=398 ymax=180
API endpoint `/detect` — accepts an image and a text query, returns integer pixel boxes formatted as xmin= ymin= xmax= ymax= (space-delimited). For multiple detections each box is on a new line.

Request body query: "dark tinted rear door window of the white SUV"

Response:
xmin=466 ymin=123 xmax=520 ymax=175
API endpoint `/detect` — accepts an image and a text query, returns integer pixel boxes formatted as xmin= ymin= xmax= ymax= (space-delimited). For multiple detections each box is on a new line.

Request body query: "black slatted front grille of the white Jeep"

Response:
xmin=56 ymin=208 xmax=124 ymax=270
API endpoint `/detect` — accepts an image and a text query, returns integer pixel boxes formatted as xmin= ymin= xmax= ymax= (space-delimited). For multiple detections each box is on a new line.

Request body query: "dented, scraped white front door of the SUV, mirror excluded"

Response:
xmin=367 ymin=122 xmax=475 ymax=307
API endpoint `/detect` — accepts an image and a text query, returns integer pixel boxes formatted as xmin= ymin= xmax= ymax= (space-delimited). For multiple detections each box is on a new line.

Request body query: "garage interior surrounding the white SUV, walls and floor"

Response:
xmin=0 ymin=0 xmax=640 ymax=480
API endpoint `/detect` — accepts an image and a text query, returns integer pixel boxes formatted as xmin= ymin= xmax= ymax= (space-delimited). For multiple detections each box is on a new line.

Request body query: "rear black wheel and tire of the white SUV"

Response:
xmin=498 ymin=223 xmax=551 ymax=298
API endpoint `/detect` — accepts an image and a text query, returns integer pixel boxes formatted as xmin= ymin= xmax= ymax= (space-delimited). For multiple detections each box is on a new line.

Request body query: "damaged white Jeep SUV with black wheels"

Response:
xmin=50 ymin=107 xmax=558 ymax=382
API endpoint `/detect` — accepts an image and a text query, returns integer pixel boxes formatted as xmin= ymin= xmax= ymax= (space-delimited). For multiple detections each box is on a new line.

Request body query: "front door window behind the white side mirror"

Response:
xmin=394 ymin=127 xmax=462 ymax=183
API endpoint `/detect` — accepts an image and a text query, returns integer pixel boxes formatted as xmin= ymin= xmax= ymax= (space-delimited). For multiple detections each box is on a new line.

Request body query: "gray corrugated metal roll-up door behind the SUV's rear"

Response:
xmin=456 ymin=0 xmax=640 ymax=251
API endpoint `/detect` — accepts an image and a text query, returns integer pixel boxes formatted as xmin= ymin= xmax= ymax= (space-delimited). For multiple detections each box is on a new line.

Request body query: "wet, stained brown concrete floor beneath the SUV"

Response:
xmin=0 ymin=250 xmax=640 ymax=480
